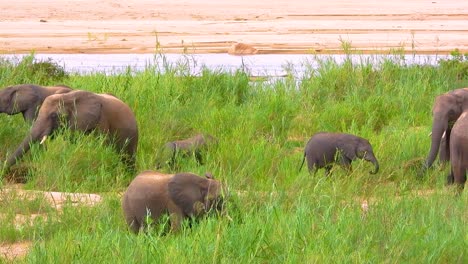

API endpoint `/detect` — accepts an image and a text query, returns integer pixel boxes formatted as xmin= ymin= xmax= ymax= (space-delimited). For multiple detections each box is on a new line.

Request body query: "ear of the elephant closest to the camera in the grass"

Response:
xmin=168 ymin=173 xmax=208 ymax=216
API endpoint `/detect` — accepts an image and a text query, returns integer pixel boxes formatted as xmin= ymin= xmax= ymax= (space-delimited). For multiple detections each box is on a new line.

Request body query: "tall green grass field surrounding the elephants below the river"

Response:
xmin=0 ymin=50 xmax=468 ymax=263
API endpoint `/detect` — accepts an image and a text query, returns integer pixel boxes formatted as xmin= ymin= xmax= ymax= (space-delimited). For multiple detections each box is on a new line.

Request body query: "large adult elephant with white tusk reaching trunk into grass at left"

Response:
xmin=6 ymin=90 xmax=138 ymax=169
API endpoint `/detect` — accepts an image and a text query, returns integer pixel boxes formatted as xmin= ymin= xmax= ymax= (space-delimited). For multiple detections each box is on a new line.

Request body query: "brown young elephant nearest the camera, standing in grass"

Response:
xmin=122 ymin=170 xmax=224 ymax=233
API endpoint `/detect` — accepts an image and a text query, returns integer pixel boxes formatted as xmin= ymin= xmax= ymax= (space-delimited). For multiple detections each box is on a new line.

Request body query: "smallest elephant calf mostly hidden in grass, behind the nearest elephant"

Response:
xmin=158 ymin=134 xmax=218 ymax=168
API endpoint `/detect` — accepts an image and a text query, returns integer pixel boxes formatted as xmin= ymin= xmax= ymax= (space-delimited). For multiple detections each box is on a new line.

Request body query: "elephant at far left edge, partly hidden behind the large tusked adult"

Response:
xmin=0 ymin=84 xmax=73 ymax=123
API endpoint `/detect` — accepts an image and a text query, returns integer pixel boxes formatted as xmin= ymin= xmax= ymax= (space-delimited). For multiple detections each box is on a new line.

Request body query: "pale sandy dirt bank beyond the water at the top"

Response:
xmin=0 ymin=0 xmax=468 ymax=54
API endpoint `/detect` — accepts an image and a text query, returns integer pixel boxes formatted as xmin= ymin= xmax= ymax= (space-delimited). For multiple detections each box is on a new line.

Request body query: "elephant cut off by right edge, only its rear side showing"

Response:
xmin=447 ymin=111 xmax=468 ymax=190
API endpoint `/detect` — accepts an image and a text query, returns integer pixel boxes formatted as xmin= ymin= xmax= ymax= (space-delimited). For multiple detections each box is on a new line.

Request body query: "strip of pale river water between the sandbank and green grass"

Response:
xmin=2 ymin=54 xmax=447 ymax=78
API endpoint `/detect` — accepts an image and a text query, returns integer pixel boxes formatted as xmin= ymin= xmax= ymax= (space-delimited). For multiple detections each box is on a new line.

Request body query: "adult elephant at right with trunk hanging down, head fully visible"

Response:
xmin=424 ymin=88 xmax=468 ymax=169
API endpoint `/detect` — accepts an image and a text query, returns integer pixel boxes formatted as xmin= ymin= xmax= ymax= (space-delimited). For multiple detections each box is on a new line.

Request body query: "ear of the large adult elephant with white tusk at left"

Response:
xmin=63 ymin=91 xmax=102 ymax=132
